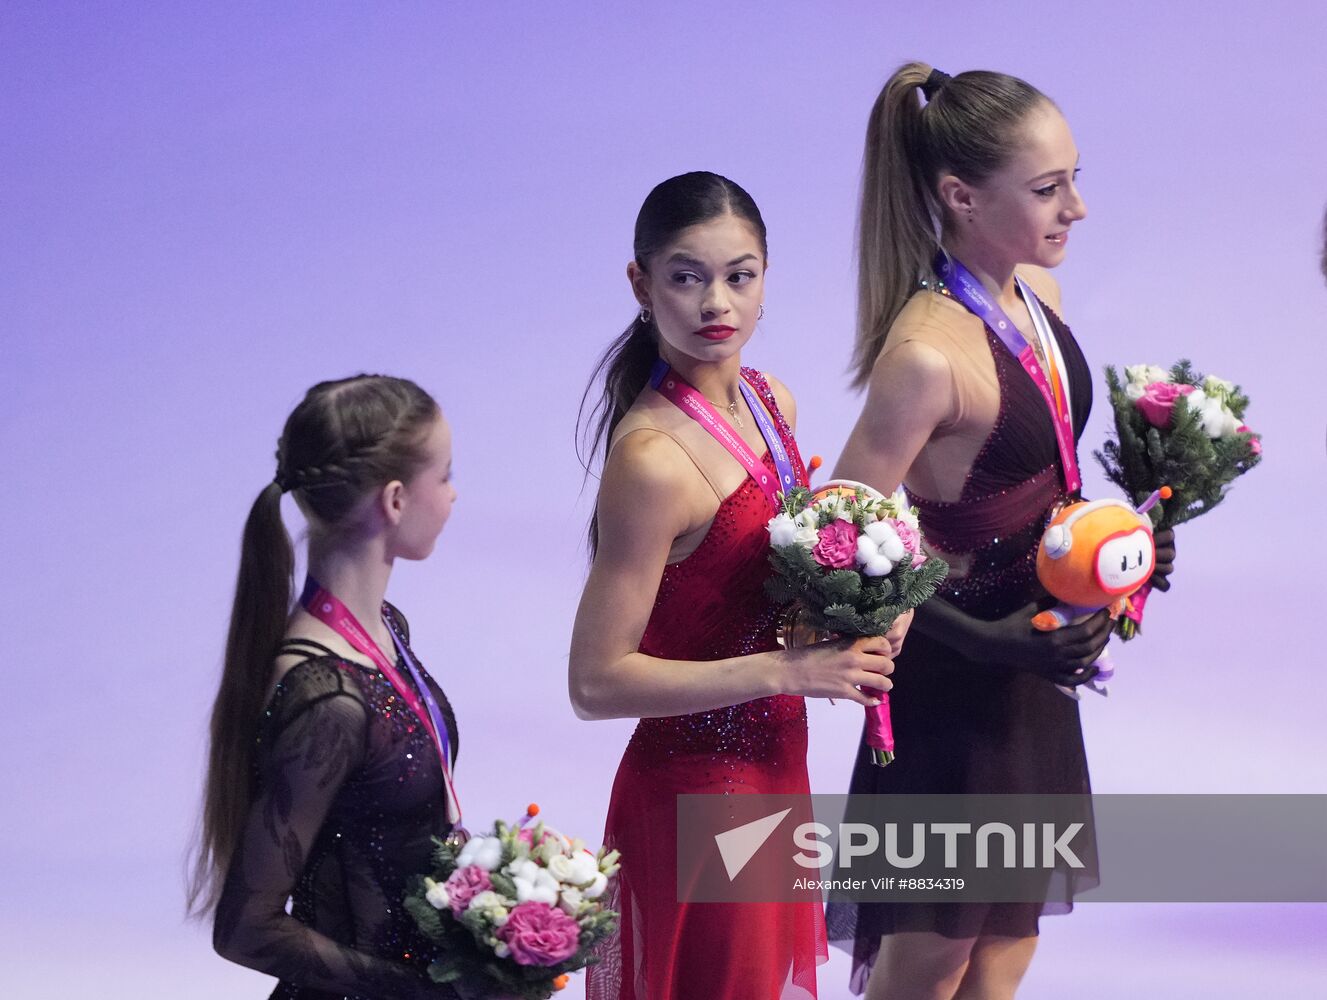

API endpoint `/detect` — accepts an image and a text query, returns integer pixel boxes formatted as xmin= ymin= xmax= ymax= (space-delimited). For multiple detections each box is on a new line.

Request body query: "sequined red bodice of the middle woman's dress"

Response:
xmin=632 ymin=369 xmax=805 ymax=757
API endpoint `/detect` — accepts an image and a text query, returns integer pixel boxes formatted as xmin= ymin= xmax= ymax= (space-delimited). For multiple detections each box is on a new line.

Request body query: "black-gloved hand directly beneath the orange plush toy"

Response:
xmin=963 ymin=601 xmax=1113 ymax=687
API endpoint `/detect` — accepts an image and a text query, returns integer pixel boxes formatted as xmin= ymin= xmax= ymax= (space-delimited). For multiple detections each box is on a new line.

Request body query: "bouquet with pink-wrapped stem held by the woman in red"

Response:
xmin=766 ymin=479 xmax=949 ymax=767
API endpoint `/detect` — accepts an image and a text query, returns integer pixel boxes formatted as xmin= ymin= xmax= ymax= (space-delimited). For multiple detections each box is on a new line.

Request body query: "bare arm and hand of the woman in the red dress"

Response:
xmin=568 ymin=432 xmax=893 ymax=719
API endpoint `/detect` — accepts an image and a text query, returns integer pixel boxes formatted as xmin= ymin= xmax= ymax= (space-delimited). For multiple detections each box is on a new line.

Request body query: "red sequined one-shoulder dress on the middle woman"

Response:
xmin=587 ymin=369 xmax=827 ymax=1000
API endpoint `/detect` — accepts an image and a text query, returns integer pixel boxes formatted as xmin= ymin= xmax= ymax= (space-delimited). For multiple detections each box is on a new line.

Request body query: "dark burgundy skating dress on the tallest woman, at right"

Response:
xmin=828 ymin=291 xmax=1096 ymax=992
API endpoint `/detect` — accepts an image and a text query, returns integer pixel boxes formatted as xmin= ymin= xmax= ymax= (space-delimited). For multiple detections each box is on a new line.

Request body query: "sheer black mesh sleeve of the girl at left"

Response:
xmin=214 ymin=660 xmax=455 ymax=1000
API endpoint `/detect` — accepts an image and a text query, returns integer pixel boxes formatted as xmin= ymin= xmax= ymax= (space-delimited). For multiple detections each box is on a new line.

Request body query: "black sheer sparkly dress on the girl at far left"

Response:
xmin=214 ymin=606 xmax=458 ymax=1000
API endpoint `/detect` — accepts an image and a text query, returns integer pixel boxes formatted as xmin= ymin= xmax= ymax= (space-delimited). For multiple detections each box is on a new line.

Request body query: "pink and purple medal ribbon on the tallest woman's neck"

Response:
xmin=936 ymin=251 xmax=1083 ymax=495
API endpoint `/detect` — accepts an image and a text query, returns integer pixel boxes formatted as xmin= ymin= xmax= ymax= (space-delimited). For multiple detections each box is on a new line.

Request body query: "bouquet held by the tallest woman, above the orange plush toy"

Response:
xmin=1096 ymin=361 xmax=1262 ymax=639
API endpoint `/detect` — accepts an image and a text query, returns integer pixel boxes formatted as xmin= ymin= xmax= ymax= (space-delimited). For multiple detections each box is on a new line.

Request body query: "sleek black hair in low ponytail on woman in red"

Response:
xmin=576 ymin=170 xmax=770 ymax=556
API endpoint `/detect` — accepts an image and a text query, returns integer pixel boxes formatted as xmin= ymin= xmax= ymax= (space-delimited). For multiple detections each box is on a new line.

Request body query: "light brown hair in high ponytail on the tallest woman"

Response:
xmin=852 ymin=62 xmax=1050 ymax=387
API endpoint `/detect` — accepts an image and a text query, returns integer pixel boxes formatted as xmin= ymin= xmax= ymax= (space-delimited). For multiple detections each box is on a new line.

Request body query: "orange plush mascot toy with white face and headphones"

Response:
xmin=1032 ymin=487 xmax=1170 ymax=698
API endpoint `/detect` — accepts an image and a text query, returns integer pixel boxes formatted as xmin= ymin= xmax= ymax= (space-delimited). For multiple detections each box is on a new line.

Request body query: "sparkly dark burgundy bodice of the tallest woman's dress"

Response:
xmin=904 ymin=291 xmax=1092 ymax=618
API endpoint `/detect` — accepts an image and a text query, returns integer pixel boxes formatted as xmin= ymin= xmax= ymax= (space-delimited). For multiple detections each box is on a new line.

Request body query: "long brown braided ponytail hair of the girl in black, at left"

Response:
xmin=188 ymin=375 xmax=441 ymax=912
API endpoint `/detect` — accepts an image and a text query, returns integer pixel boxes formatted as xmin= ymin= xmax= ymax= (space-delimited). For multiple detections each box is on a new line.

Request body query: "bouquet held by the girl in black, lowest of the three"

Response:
xmin=405 ymin=805 xmax=618 ymax=1000
